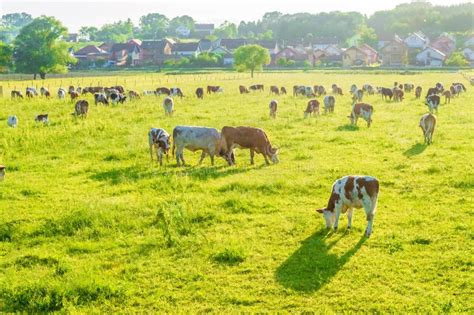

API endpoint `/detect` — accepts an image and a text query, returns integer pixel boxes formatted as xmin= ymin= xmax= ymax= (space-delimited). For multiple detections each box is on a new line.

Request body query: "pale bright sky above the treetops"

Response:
xmin=0 ymin=0 xmax=469 ymax=32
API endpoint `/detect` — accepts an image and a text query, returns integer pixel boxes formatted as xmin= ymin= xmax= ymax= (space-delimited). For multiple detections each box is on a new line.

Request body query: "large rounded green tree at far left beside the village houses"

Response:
xmin=13 ymin=16 xmax=75 ymax=79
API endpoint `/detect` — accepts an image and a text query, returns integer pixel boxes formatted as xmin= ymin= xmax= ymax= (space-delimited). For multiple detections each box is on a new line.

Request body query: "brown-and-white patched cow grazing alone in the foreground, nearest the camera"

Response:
xmin=316 ymin=175 xmax=379 ymax=237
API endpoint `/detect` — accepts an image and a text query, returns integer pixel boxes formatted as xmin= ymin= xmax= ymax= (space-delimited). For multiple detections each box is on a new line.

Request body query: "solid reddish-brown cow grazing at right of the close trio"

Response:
xmin=221 ymin=126 xmax=279 ymax=165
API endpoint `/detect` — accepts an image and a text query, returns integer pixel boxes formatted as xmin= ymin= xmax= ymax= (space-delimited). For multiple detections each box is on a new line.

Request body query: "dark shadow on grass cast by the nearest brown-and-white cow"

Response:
xmin=275 ymin=230 xmax=367 ymax=293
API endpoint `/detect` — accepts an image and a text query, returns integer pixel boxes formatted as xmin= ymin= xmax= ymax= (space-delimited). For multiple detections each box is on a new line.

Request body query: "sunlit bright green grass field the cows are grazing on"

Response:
xmin=0 ymin=73 xmax=474 ymax=313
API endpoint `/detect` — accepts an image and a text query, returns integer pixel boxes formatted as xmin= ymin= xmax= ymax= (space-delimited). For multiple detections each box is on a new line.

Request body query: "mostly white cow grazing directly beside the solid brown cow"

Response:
xmin=173 ymin=126 xmax=227 ymax=166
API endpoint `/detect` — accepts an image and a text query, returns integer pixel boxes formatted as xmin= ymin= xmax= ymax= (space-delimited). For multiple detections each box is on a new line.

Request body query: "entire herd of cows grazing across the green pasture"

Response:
xmin=0 ymin=82 xmax=466 ymax=237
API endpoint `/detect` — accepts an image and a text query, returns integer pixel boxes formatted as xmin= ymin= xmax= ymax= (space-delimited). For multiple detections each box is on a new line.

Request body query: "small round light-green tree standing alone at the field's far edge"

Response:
xmin=234 ymin=45 xmax=271 ymax=78
